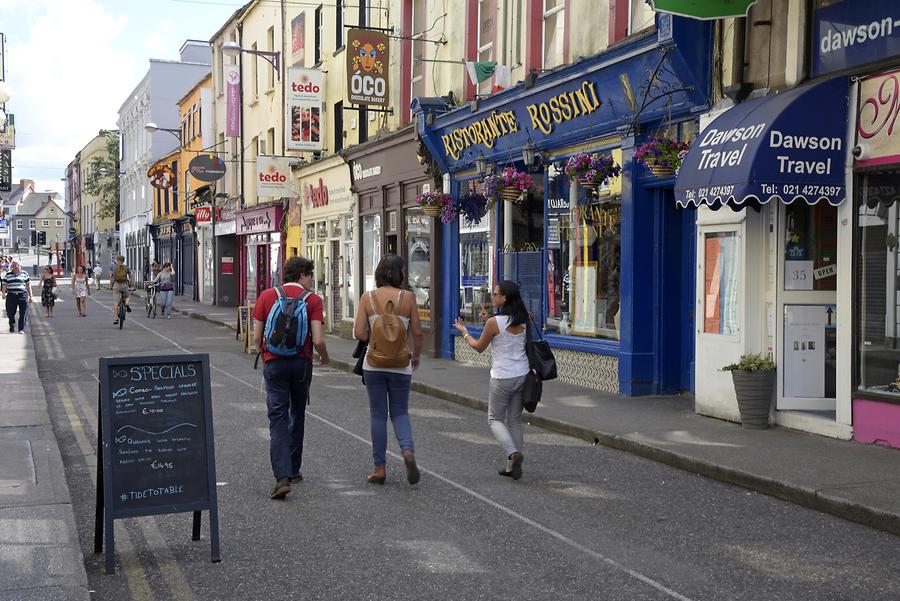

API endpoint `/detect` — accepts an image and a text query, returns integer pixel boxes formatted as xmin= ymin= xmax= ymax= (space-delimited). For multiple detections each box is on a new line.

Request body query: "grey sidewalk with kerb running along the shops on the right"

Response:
xmin=162 ymin=298 xmax=900 ymax=535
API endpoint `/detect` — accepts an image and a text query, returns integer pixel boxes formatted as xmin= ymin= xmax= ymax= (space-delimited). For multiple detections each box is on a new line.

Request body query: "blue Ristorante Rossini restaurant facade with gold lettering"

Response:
xmin=412 ymin=15 xmax=712 ymax=395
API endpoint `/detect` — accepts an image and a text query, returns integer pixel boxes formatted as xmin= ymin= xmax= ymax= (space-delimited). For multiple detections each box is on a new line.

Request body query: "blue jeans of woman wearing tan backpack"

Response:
xmin=364 ymin=370 xmax=415 ymax=465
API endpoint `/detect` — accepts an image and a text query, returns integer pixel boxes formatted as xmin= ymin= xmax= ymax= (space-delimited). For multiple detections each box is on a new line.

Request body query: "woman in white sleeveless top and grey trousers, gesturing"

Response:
xmin=455 ymin=280 xmax=530 ymax=480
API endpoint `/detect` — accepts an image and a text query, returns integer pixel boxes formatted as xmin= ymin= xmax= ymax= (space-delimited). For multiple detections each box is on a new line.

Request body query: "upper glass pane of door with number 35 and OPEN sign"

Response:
xmin=784 ymin=202 xmax=837 ymax=290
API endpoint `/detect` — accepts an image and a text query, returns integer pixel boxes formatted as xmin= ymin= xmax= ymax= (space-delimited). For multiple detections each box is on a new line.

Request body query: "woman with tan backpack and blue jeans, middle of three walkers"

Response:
xmin=353 ymin=255 xmax=422 ymax=484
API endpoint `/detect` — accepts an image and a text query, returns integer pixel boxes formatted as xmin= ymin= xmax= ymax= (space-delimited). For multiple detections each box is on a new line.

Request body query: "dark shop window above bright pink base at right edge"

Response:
xmin=854 ymin=170 xmax=900 ymax=399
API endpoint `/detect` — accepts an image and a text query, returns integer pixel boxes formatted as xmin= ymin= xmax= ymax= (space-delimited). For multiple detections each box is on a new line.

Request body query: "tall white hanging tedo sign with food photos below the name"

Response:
xmin=284 ymin=68 xmax=325 ymax=151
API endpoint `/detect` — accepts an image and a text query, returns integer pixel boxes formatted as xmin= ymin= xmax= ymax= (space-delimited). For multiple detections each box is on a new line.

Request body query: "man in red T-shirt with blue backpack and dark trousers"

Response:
xmin=251 ymin=257 xmax=328 ymax=499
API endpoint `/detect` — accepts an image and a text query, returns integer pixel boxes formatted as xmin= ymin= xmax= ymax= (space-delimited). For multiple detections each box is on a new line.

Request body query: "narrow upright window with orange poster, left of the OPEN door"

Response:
xmin=703 ymin=232 xmax=740 ymax=336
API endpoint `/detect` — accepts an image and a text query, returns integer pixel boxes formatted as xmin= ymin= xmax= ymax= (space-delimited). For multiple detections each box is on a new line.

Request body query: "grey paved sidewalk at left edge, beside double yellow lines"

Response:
xmin=0 ymin=326 xmax=90 ymax=601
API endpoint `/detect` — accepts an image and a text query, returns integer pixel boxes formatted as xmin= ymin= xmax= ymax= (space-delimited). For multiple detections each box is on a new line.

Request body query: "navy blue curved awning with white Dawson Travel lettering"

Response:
xmin=675 ymin=77 xmax=850 ymax=209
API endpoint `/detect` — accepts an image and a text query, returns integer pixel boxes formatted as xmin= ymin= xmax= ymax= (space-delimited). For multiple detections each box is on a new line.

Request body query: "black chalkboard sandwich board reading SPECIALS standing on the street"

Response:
xmin=94 ymin=354 xmax=220 ymax=573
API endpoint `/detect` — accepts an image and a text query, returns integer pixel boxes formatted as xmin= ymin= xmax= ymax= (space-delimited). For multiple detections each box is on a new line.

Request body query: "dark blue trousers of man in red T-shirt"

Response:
xmin=263 ymin=357 xmax=312 ymax=479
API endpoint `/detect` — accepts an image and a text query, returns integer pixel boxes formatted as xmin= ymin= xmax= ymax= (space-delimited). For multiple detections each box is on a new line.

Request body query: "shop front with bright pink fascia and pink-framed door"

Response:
xmin=235 ymin=204 xmax=284 ymax=305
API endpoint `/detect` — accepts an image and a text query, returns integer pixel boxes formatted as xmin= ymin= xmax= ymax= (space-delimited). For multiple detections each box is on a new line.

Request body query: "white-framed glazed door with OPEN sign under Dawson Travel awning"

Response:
xmin=774 ymin=201 xmax=838 ymax=412
